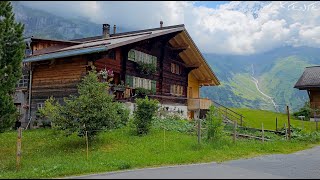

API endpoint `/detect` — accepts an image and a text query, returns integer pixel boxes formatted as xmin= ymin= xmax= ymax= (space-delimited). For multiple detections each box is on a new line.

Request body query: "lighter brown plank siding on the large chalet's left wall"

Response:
xmin=31 ymin=57 xmax=87 ymax=113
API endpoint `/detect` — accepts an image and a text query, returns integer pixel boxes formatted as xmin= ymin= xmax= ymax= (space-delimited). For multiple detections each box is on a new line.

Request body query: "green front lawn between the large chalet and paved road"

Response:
xmin=0 ymin=129 xmax=316 ymax=178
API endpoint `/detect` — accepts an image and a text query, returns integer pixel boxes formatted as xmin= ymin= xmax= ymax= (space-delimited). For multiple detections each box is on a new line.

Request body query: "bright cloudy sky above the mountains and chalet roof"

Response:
xmin=21 ymin=1 xmax=320 ymax=54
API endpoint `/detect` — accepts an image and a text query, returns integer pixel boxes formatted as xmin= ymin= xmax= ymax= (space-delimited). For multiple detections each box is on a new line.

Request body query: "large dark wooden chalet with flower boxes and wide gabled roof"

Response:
xmin=15 ymin=22 xmax=220 ymax=127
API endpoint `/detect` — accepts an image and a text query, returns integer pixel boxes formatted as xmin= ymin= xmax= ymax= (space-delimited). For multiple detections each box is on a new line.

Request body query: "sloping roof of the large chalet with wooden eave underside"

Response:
xmin=23 ymin=24 xmax=220 ymax=86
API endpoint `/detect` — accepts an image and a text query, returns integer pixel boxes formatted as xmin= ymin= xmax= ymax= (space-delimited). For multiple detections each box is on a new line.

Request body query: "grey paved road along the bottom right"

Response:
xmin=70 ymin=146 xmax=320 ymax=179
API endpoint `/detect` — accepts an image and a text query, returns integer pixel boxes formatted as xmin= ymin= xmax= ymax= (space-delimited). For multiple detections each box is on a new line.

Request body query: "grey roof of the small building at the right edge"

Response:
xmin=294 ymin=66 xmax=320 ymax=90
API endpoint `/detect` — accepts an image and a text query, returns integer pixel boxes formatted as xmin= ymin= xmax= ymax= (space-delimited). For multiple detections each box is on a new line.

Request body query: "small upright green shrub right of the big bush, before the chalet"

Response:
xmin=134 ymin=96 xmax=159 ymax=135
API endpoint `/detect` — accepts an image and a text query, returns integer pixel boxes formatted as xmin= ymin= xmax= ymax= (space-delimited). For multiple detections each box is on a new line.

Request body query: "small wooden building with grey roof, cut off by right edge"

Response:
xmin=294 ymin=66 xmax=320 ymax=121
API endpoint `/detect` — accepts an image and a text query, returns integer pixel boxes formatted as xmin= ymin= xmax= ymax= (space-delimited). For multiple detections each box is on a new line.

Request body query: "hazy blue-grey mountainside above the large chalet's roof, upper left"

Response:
xmin=11 ymin=1 xmax=129 ymax=40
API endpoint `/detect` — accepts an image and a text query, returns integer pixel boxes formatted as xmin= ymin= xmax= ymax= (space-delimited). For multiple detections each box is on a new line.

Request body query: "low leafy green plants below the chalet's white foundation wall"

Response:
xmin=152 ymin=114 xmax=194 ymax=133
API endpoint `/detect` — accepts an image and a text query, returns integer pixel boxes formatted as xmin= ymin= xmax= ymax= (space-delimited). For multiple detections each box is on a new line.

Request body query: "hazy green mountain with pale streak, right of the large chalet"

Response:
xmin=201 ymin=47 xmax=320 ymax=112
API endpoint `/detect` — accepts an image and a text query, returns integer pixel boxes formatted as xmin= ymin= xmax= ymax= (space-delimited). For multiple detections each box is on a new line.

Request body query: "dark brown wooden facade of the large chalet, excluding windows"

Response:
xmin=25 ymin=34 xmax=190 ymax=120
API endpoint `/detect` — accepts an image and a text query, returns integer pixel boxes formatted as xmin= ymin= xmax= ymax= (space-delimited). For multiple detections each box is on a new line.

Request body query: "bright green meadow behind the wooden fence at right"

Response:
xmin=232 ymin=108 xmax=320 ymax=132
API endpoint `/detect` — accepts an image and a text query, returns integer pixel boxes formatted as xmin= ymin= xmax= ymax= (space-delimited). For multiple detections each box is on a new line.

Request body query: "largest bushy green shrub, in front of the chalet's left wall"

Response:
xmin=41 ymin=70 xmax=128 ymax=139
